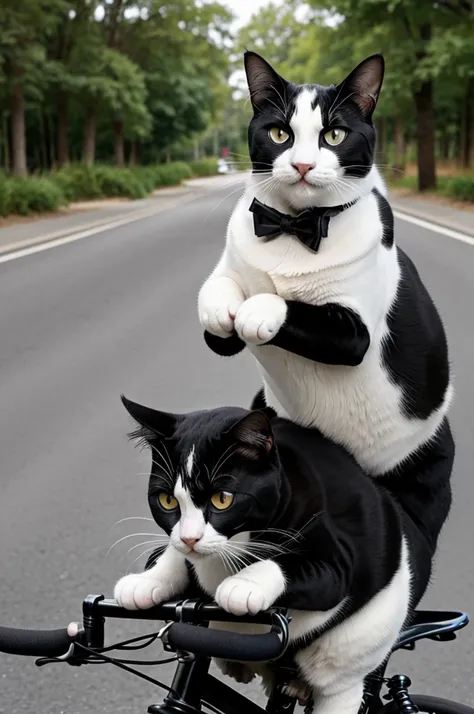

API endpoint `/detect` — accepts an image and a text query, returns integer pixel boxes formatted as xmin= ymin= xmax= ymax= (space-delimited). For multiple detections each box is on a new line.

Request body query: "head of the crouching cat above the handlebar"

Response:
xmin=122 ymin=397 xmax=281 ymax=562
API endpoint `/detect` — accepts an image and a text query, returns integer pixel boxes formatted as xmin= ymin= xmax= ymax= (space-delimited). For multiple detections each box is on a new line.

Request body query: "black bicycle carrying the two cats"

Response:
xmin=0 ymin=595 xmax=474 ymax=714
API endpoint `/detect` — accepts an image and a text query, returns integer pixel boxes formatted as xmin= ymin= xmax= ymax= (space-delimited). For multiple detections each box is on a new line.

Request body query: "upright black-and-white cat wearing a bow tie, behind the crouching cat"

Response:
xmin=198 ymin=52 xmax=454 ymax=551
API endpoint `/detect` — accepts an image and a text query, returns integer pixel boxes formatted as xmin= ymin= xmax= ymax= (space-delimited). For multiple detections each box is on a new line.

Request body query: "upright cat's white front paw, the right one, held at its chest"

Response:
xmin=235 ymin=293 xmax=287 ymax=345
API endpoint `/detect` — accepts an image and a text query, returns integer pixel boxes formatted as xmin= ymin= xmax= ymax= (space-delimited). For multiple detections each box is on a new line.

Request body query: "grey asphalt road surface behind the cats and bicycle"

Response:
xmin=0 ymin=177 xmax=474 ymax=714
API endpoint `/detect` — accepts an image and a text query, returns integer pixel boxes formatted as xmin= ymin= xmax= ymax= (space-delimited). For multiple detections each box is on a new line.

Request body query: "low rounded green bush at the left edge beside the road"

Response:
xmin=0 ymin=177 xmax=67 ymax=216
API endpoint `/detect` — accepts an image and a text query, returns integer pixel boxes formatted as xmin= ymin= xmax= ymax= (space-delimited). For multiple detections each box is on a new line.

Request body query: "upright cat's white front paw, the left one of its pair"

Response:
xmin=198 ymin=278 xmax=245 ymax=337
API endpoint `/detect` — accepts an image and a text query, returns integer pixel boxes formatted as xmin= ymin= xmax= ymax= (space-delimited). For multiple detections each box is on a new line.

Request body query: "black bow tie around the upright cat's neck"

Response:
xmin=249 ymin=198 xmax=355 ymax=253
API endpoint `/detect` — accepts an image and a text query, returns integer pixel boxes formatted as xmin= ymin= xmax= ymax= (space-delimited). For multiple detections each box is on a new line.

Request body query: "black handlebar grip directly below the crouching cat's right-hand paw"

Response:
xmin=167 ymin=622 xmax=285 ymax=662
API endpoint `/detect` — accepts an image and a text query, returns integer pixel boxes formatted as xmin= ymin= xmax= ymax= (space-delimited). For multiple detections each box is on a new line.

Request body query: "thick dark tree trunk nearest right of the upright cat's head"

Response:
xmin=413 ymin=80 xmax=436 ymax=191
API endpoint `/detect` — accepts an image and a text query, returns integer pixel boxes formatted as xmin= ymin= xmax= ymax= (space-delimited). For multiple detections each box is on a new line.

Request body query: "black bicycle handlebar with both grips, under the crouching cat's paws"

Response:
xmin=0 ymin=595 xmax=288 ymax=662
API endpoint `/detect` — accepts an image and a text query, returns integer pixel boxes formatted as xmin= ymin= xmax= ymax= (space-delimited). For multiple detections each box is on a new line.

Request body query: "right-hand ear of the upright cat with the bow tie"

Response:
xmin=337 ymin=54 xmax=385 ymax=118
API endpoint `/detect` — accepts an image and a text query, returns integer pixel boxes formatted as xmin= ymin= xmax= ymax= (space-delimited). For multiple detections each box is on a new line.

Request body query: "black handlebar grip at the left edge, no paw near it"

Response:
xmin=0 ymin=627 xmax=74 ymax=657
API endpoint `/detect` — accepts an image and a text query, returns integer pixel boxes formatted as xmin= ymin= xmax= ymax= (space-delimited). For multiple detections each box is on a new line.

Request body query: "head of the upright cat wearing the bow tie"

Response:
xmin=245 ymin=52 xmax=384 ymax=210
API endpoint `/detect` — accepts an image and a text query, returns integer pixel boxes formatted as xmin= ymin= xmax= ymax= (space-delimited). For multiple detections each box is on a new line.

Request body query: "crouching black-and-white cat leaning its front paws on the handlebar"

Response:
xmin=115 ymin=399 xmax=431 ymax=714
